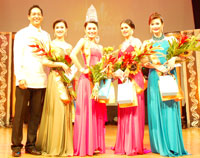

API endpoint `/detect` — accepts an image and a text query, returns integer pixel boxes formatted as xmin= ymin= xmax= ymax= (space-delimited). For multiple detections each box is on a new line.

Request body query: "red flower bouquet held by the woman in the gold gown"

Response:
xmin=29 ymin=38 xmax=76 ymax=104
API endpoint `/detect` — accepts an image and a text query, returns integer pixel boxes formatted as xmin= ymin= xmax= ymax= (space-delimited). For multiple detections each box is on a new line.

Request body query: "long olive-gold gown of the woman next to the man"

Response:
xmin=36 ymin=40 xmax=74 ymax=156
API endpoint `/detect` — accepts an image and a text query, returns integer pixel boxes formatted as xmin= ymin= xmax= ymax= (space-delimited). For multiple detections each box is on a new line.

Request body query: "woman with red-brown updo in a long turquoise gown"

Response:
xmin=144 ymin=13 xmax=188 ymax=157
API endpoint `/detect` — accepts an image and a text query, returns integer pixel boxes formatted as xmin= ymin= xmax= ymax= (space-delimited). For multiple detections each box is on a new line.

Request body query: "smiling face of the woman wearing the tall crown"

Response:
xmin=85 ymin=23 xmax=98 ymax=39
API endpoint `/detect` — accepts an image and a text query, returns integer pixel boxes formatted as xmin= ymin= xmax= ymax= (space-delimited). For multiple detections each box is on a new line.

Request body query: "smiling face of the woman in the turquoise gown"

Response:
xmin=150 ymin=18 xmax=164 ymax=36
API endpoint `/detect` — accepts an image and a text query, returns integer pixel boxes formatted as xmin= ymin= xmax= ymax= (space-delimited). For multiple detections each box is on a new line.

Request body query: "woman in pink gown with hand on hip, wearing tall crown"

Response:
xmin=71 ymin=7 xmax=106 ymax=156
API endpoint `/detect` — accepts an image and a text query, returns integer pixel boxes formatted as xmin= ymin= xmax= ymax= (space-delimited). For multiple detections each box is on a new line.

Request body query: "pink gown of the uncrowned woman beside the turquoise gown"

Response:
xmin=114 ymin=45 xmax=145 ymax=155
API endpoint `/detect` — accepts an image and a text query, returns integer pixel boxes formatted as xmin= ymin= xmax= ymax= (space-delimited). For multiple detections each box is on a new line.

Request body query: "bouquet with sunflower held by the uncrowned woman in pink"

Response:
xmin=114 ymin=42 xmax=162 ymax=98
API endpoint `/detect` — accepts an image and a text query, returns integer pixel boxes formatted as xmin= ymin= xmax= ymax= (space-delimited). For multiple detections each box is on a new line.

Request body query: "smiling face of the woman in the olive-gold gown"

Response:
xmin=54 ymin=22 xmax=67 ymax=38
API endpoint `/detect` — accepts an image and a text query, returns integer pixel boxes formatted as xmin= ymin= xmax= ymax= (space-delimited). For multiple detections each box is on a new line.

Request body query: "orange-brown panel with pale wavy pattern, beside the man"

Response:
xmin=0 ymin=32 xmax=13 ymax=126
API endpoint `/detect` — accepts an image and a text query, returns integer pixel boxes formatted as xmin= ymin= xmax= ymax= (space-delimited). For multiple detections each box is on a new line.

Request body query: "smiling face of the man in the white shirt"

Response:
xmin=28 ymin=8 xmax=43 ymax=28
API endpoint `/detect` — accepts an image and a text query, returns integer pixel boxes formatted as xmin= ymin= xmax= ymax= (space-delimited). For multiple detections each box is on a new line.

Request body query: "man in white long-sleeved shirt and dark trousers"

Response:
xmin=11 ymin=5 xmax=50 ymax=157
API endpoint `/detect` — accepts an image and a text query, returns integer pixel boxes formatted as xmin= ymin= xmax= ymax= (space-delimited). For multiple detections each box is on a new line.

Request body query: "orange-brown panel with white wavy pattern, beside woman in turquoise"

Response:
xmin=181 ymin=29 xmax=200 ymax=127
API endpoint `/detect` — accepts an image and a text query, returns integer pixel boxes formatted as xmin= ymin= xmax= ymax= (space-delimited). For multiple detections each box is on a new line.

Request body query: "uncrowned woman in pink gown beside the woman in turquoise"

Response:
xmin=115 ymin=19 xmax=145 ymax=155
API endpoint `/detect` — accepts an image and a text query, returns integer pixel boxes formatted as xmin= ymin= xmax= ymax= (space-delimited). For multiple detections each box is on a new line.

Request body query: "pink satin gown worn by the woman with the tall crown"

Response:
xmin=73 ymin=48 xmax=106 ymax=156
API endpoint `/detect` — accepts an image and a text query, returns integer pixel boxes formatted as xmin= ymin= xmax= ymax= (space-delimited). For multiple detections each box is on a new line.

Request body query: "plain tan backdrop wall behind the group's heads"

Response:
xmin=0 ymin=0 xmax=194 ymax=46
